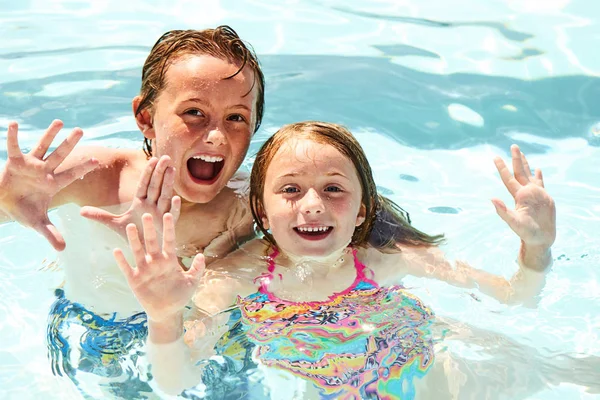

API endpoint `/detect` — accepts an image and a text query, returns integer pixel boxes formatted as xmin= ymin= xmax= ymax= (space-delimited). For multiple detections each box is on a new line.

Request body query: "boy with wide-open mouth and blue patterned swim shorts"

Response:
xmin=0 ymin=26 xmax=264 ymax=396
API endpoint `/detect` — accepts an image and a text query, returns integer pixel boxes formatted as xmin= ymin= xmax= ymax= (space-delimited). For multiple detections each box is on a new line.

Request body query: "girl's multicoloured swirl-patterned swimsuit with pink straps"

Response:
xmin=232 ymin=249 xmax=434 ymax=399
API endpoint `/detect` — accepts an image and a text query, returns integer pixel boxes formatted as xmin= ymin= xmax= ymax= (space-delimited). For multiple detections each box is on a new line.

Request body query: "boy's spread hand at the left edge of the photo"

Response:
xmin=0 ymin=120 xmax=98 ymax=251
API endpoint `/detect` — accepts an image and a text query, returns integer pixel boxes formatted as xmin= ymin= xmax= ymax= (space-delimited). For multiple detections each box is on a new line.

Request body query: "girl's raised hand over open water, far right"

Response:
xmin=492 ymin=145 xmax=556 ymax=248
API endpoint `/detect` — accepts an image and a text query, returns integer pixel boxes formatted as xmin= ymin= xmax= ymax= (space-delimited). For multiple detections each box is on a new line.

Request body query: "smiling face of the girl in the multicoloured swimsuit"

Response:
xmin=263 ymin=139 xmax=365 ymax=257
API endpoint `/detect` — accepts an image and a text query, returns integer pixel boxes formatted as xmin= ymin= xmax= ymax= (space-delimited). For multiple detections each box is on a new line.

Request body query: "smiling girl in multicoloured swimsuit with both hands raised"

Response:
xmin=115 ymin=122 xmax=554 ymax=398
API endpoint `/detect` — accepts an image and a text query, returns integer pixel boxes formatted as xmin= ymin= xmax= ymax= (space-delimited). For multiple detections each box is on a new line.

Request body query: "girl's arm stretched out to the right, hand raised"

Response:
xmin=371 ymin=145 xmax=556 ymax=305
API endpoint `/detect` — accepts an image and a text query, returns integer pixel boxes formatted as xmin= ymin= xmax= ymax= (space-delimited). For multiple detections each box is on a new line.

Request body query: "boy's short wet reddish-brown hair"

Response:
xmin=135 ymin=25 xmax=265 ymax=157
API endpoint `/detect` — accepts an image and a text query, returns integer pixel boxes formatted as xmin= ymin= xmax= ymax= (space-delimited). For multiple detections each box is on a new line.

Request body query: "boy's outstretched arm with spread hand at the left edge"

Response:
xmin=0 ymin=120 xmax=144 ymax=250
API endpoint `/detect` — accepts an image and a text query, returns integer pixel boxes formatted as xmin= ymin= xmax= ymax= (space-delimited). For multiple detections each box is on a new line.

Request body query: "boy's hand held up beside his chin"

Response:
xmin=81 ymin=156 xmax=181 ymax=242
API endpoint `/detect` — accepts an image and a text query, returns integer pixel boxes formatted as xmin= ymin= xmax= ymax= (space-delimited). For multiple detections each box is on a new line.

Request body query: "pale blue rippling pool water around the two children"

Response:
xmin=0 ymin=0 xmax=600 ymax=399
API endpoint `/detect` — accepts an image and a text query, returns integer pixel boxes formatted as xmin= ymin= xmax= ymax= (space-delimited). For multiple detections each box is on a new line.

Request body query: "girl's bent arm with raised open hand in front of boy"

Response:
xmin=115 ymin=213 xmax=264 ymax=395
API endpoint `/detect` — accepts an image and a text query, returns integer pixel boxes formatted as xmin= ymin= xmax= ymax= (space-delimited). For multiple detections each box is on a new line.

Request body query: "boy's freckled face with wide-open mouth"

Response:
xmin=134 ymin=55 xmax=257 ymax=203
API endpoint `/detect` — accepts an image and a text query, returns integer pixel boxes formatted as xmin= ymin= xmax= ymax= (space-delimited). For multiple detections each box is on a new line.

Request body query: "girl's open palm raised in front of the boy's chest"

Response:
xmin=114 ymin=213 xmax=204 ymax=322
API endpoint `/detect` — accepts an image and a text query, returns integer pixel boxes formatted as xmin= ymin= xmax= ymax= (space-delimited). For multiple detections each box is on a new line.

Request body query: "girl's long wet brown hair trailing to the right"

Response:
xmin=250 ymin=121 xmax=444 ymax=251
